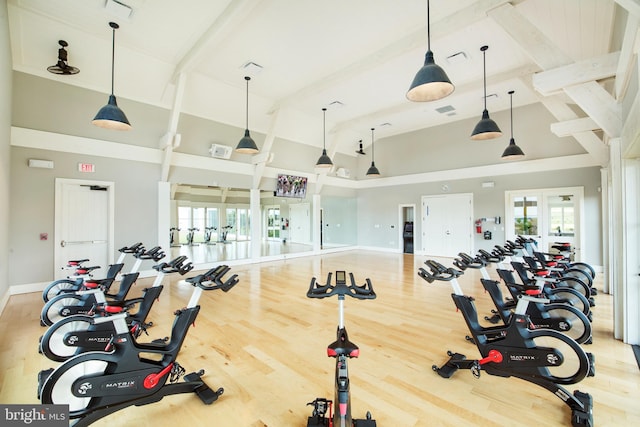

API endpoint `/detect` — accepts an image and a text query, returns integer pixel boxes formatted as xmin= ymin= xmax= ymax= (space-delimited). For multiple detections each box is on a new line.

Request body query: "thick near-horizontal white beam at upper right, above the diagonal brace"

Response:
xmin=533 ymin=52 xmax=620 ymax=96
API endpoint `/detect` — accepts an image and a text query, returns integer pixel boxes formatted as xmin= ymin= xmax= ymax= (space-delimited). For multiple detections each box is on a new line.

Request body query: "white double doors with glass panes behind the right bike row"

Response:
xmin=505 ymin=187 xmax=584 ymax=261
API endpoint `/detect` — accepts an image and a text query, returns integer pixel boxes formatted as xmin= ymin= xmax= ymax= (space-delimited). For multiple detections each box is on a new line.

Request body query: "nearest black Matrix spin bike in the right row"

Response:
xmin=418 ymin=260 xmax=594 ymax=427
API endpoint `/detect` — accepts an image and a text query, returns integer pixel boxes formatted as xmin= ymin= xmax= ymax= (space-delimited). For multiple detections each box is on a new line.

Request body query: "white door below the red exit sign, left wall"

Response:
xmin=54 ymin=178 xmax=114 ymax=279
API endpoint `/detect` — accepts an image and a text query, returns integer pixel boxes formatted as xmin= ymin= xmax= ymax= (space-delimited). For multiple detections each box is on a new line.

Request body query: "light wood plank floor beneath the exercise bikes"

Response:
xmin=0 ymin=251 xmax=640 ymax=427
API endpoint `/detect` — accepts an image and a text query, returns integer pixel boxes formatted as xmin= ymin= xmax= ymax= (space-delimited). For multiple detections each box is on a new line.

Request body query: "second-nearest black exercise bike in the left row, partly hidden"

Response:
xmin=40 ymin=255 xmax=194 ymax=362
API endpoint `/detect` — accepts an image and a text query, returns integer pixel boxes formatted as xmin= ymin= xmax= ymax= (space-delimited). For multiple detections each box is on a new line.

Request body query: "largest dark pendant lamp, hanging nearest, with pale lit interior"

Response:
xmin=407 ymin=0 xmax=455 ymax=102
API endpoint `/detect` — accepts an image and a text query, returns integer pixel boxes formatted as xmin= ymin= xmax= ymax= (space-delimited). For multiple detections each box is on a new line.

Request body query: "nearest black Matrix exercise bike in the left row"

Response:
xmin=38 ymin=264 xmax=238 ymax=427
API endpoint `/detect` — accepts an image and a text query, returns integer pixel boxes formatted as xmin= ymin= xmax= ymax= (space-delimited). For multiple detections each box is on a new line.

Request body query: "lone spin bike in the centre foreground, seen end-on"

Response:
xmin=307 ymin=271 xmax=376 ymax=427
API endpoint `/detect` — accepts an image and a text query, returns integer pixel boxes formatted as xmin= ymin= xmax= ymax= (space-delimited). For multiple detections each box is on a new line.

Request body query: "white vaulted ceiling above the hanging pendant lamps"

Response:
xmin=8 ymin=0 xmax=616 ymax=154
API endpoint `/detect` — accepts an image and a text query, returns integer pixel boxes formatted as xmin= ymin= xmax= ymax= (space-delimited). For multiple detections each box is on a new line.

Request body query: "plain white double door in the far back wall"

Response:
xmin=421 ymin=193 xmax=473 ymax=257
